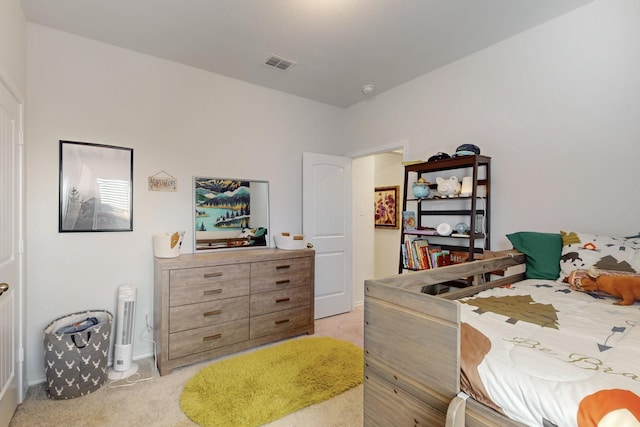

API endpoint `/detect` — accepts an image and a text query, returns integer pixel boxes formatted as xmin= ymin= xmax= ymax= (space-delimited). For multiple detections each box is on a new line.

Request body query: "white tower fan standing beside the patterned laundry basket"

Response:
xmin=109 ymin=285 xmax=138 ymax=380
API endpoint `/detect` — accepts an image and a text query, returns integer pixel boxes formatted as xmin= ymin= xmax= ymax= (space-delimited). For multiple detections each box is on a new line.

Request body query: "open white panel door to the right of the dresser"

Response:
xmin=302 ymin=153 xmax=353 ymax=319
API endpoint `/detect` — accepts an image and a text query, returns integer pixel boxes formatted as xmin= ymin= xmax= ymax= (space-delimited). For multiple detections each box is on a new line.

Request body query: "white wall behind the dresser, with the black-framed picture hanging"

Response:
xmin=26 ymin=24 xmax=345 ymax=383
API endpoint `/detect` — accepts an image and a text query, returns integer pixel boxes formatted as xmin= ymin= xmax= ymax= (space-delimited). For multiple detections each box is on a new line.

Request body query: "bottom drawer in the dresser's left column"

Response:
xmin=169 ymin=318 xmax=249 ymax=359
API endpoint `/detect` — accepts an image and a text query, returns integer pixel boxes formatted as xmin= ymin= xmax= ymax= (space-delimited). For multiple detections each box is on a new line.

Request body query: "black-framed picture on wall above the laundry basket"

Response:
xmin=58 ymin=141 xmax=133 ymax=233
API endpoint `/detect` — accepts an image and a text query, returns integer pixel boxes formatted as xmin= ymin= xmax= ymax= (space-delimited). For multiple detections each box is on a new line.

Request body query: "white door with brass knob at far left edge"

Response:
xmin=0 ymin=79 xmax=22 ymax=426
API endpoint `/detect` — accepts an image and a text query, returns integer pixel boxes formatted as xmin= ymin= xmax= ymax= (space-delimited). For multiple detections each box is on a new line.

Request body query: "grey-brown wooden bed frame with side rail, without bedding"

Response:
xmin=364 ymin=251 xmax=525 ymax=427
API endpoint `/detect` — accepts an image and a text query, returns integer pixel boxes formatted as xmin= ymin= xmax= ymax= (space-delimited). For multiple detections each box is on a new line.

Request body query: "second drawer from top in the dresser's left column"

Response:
xmin=169 ymin=279 xmax=250 ymax=307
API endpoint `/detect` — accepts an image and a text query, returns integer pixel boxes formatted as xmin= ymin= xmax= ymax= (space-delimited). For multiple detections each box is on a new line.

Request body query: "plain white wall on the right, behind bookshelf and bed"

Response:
xmin=346 ymin=0 xmax=640 ymax=249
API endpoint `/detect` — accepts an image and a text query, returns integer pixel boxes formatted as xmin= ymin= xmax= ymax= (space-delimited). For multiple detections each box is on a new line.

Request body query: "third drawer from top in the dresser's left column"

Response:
xmin=169 ymin=296 xmax=249 ymax=333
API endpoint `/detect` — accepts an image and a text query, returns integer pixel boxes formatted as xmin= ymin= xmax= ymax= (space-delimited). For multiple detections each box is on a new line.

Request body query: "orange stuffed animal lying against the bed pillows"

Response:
xmin=570 ymin=267 xmax=640 ymax=305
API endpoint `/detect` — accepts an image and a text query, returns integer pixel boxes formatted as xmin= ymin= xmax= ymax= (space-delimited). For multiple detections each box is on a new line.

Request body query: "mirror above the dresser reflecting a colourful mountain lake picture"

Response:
xmin=193 ymin=177 xmax=269 ymax=252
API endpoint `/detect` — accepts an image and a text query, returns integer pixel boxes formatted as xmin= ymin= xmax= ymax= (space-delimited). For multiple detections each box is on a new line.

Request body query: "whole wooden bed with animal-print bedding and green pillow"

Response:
xmin=364 ymin=232 xmax=640 ymax=427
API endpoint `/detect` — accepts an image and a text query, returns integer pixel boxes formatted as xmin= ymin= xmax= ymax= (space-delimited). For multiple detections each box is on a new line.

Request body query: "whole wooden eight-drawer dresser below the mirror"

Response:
xmin=154 ymin=249 xmax=315 ymax=375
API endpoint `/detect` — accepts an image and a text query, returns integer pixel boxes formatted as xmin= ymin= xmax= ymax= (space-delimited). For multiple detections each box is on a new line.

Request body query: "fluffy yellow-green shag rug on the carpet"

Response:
xmin=180 ymin=337 xmax=364 ymax=427
